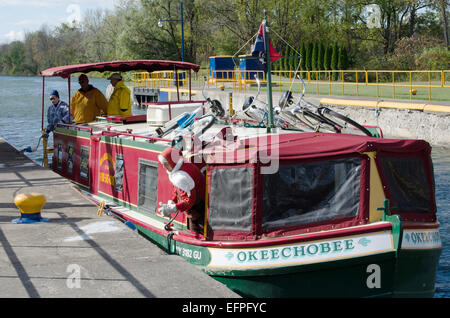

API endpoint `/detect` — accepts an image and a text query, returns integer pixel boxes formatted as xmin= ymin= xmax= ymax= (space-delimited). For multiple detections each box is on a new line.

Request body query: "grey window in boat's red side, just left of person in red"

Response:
xmin=138 ymin=159 xmax=158 ymax=213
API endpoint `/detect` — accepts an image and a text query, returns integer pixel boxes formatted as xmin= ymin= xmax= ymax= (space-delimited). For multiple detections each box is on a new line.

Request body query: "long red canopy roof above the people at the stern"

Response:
xmin=41 ymin=60 xmax=200 ymax=78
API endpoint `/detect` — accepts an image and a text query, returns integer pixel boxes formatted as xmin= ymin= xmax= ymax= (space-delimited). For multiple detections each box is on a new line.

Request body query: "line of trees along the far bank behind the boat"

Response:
xmin=0 ymin=0 xmax=450 ymax=75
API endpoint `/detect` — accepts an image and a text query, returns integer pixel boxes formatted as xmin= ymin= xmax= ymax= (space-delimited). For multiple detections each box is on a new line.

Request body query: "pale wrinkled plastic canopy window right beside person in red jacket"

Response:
xmin=208 ymin=167 xmax=254 ymax=232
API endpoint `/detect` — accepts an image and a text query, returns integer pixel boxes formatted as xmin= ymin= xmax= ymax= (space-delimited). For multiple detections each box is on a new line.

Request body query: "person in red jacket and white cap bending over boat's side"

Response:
xmin=158 ymin=147 xmax=205 ymax=233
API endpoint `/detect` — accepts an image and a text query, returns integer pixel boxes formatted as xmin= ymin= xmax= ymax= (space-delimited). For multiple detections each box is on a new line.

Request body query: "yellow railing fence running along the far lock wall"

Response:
xmin=132 ymin=68 xmax=450 ymax=100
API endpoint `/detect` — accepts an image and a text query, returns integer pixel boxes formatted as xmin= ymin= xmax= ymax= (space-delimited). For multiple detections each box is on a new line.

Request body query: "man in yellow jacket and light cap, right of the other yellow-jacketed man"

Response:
xmin=108 ymin=73 xmax=132 ymax=116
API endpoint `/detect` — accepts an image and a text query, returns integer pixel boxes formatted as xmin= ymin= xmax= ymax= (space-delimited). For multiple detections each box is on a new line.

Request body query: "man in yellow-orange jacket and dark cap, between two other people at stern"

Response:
xmin=70 ymin=74 xmax=108 ymax=124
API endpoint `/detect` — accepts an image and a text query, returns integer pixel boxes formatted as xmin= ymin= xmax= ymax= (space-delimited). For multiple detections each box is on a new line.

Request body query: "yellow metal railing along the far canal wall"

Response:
xmin=132 ymin=68 xmax=450 ymax=100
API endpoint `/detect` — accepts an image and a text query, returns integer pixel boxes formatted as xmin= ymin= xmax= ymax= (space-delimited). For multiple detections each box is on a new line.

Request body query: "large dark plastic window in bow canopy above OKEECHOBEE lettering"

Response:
xmin=262 ymin=158 xmax=361 ymax=230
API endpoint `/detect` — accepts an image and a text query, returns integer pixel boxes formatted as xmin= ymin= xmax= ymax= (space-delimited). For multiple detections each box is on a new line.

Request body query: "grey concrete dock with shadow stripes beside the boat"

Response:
xmin=0 ymin=138 xmax=239 ymax=298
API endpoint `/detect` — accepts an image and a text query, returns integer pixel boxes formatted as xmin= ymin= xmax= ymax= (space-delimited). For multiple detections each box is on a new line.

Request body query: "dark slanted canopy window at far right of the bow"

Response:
xmin=379 ymin=156 xmax=431 ymax=213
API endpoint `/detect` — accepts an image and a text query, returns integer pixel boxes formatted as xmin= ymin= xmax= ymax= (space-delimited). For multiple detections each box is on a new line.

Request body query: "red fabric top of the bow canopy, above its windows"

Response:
xmin=204 ymin=133 xmax=431 ymax=164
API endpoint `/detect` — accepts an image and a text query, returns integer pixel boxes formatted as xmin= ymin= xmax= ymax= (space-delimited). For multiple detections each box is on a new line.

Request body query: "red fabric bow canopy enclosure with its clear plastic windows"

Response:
xmin=202 ymin=133 xmax=436 ymax=240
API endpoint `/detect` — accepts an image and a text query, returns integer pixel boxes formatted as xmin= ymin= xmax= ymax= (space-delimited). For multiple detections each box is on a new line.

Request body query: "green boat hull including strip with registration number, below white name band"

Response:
xmin=137 ymin=225 xmax=442 ymax=298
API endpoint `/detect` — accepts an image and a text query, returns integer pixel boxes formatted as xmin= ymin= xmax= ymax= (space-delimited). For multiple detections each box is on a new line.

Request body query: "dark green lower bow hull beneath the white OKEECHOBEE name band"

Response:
xmin=212 ymin=249 xmax=441 ymax=298
